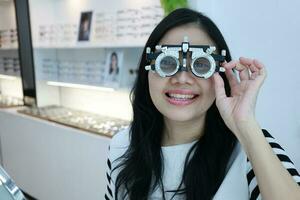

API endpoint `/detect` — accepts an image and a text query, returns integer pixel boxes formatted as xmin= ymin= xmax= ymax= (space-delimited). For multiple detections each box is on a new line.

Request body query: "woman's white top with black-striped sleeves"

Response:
xmin=105 ymin=129 xmax=300 ymax=200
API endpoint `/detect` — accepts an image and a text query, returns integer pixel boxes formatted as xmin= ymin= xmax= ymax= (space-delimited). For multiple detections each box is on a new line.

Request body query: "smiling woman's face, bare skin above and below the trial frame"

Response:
xmin=148 ymin=24 xmax=215 ymax=122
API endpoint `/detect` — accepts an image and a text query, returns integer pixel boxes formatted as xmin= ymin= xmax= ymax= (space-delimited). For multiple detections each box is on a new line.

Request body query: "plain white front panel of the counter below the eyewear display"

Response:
xmin=0 ymin=108 xmax=110 ymax=200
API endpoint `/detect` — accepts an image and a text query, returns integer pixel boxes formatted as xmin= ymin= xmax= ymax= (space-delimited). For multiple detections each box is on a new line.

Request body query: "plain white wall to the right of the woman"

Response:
xmin=192 ymin=0 xmax=300 ymax=170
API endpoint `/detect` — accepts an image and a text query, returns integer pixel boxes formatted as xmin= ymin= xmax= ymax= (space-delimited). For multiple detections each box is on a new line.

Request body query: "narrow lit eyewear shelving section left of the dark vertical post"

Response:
xmin=0 ymin=0 xmax=23 ymax=108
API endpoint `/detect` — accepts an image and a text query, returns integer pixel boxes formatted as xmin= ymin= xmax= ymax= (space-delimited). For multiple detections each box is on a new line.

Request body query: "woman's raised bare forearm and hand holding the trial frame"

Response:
xmin=214 ymin=58 xmax=300 ymax=200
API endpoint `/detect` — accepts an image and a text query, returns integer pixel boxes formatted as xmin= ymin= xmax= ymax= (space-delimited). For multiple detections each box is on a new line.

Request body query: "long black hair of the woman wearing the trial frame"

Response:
xmin=113 ymin=8 xmax=237 ymax=200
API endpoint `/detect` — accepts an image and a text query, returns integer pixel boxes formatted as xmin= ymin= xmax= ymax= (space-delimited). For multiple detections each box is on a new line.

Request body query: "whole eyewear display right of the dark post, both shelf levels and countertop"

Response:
xmin=19 ymin=0 xmax=163 ymax=137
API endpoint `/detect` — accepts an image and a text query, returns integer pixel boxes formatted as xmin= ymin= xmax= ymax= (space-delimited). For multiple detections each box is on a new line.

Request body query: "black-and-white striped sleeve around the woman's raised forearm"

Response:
xmin=247 ymin=130 xmax=300 ymax=200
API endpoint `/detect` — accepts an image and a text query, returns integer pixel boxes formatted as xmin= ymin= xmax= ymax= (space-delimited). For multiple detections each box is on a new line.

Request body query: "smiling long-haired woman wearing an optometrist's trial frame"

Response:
xmin=105 ymin=9 xmax=300 ymax=200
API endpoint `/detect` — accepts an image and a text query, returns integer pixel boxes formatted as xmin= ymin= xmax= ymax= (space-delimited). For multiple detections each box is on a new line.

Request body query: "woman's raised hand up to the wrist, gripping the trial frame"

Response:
xmin=213 ymin=57 xmax=266 ymax=138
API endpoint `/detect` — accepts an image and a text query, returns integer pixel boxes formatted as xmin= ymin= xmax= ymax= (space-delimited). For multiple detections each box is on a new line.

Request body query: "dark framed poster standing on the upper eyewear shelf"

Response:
xmin=78 ymin=11 xmax=93 ymax=41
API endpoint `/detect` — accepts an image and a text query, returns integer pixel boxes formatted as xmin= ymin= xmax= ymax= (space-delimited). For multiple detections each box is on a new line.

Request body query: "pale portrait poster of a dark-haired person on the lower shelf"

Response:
xmin=104 ymin=51 xmax=123 ymax=88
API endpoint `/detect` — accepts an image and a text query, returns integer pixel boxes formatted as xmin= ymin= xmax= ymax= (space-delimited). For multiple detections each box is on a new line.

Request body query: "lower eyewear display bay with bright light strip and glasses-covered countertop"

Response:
xmin=29 ymin=47 xmax=141 ymax=137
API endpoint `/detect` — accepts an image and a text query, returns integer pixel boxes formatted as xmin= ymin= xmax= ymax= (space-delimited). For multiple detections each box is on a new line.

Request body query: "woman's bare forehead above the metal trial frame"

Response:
xmin=159 ymin=24 xmax=215 ymax=45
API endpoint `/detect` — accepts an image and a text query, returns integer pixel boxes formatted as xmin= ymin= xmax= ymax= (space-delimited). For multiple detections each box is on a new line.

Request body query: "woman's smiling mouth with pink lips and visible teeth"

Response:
xmin=164 ymin=90 xmax=199 ymax=106
